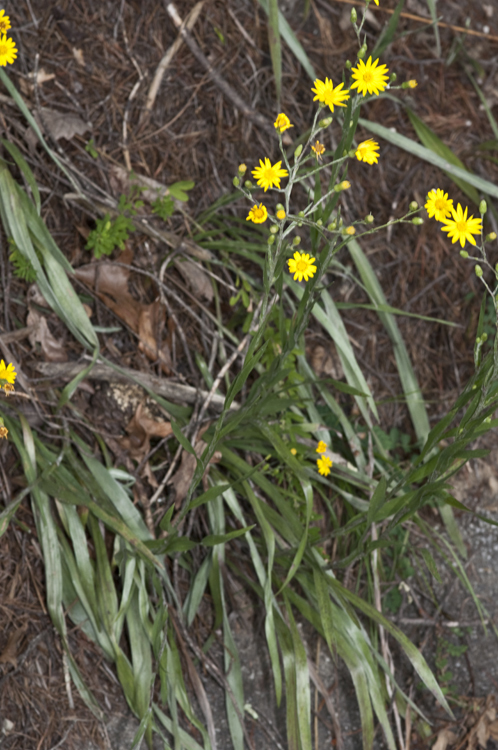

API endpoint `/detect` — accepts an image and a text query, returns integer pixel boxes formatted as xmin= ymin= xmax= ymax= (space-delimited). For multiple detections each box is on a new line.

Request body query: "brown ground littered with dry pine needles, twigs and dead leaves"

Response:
xmin=0 ymin=0 xmax=498 ymax=750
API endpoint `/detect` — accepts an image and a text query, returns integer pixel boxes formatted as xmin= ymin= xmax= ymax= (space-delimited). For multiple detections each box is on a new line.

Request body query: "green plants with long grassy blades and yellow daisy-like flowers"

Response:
xmin=0 ymin=0 xmax=498 ymax=750
